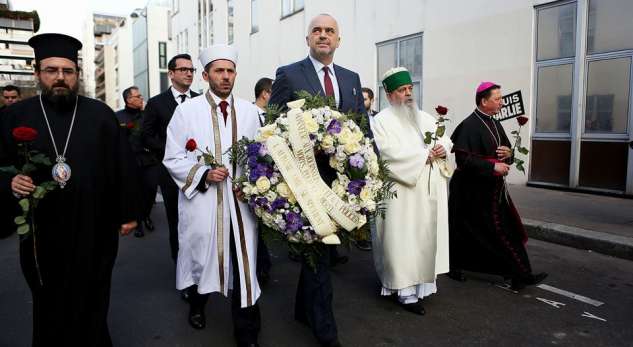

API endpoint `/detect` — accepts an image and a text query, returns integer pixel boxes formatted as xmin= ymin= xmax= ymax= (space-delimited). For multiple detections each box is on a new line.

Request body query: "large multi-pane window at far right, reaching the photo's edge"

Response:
xmin=530 ymin=0 xmax=633 ymax=194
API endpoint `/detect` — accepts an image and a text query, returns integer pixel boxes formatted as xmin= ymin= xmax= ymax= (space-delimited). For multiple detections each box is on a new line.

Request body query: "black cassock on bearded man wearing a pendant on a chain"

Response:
xmin=0 ymin=96 xmax=138 ymax=346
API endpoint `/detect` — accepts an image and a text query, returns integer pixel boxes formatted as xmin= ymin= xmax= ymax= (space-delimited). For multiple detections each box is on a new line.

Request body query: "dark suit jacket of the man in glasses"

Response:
xmin=141 ymin=87 xmax=199 ymax=162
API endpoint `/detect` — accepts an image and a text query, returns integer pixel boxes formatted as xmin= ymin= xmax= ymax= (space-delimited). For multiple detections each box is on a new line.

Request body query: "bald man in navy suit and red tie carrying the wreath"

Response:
xmin=269 ymin=14 xmax=371 ymax=346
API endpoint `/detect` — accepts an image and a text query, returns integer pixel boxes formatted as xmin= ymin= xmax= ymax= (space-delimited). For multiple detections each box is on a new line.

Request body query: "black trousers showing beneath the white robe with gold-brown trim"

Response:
xmin=189 ymin=229 xmax=261 ymax=347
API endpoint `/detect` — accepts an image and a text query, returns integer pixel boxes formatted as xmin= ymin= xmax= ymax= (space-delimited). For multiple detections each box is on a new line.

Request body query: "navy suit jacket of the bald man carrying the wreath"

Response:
xmin=268 ymin=57 xmax=365 ymax=114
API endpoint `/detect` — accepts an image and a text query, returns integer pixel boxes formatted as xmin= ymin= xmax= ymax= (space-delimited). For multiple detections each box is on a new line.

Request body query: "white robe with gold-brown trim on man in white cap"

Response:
xmin=163 ymin=92 xmax=260 ymax=307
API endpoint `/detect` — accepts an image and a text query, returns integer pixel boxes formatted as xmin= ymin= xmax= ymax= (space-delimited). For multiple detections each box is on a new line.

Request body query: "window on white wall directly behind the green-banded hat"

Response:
xmin=376 ymin=34 xmax=422 ymax=110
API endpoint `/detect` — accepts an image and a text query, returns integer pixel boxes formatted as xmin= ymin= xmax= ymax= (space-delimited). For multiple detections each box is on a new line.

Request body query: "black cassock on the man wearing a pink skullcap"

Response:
xmin=448 ymin=110 xmax=532 ymax=279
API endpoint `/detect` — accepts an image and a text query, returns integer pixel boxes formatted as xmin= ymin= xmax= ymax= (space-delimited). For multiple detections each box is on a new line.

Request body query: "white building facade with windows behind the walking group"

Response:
xmin=171 ymin=0 xmax=633 ymax=195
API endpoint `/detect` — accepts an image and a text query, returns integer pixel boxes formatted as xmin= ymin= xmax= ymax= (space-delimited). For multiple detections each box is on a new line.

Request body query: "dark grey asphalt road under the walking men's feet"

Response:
xmin=0 ymin=205 xmax=633 ymax=347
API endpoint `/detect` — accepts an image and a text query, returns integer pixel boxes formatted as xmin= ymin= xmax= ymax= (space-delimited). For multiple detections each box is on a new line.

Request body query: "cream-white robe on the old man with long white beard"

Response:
xmin=371 ymin=108 xmax=452 ymax=296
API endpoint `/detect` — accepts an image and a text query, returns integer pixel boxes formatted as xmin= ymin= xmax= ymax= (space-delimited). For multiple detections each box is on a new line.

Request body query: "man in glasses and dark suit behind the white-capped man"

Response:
xmin=141 ymin=54 xmax=198 ymax=262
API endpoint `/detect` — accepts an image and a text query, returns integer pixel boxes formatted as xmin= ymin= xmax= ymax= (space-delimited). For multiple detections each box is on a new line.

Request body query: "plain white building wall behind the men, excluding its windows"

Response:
xmin=172 ymin=0 xmax=548 ymax=183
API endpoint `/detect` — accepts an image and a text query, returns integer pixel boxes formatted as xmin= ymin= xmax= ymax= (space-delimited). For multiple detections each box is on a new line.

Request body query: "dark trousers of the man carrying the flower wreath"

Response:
xmin=295 ymin=245 xmax=338 ymax=344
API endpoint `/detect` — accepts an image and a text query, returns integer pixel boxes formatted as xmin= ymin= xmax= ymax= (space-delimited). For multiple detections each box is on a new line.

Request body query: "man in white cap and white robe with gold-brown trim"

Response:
xmin=163 ymin=44 xmax=261 ymax=346
